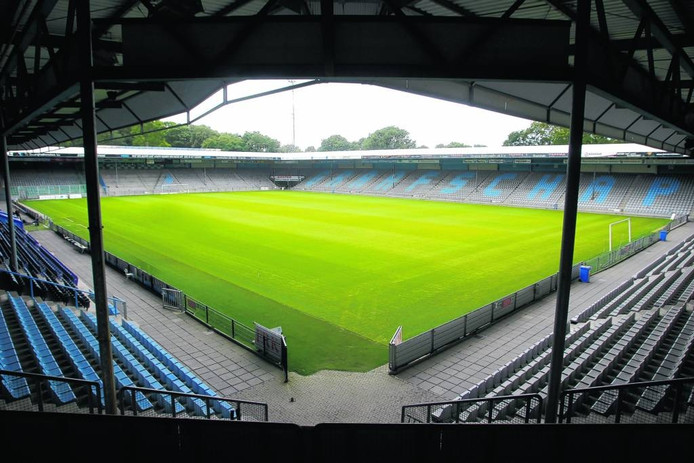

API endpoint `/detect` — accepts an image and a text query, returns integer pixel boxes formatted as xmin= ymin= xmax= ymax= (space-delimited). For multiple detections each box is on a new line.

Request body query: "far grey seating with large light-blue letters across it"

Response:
xmin=294 ymin=169 xmax=694 ymax=217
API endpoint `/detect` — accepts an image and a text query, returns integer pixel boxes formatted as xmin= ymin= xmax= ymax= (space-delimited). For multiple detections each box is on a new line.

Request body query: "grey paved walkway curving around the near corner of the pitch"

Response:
xmin=28 ymin=224 xmax=694 ymax=425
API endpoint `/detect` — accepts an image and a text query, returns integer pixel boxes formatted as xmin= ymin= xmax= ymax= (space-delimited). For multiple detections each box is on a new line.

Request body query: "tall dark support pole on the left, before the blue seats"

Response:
xmin=77 ymin=0 xmax=117 ymax=415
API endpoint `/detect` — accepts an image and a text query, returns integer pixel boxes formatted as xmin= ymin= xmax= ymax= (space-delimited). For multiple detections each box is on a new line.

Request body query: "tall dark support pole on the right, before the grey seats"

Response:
xmin=545 ymin=0 xmax=591 ymax=423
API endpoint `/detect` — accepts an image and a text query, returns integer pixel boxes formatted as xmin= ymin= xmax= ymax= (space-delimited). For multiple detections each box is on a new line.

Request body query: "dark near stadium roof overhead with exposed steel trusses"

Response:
xmin=0 ymin=0 xmax=694 ymax=154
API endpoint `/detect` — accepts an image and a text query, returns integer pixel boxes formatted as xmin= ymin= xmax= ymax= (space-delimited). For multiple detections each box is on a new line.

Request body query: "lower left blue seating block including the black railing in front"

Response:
xmin=0 ymin=293 xmax=268 ymax=421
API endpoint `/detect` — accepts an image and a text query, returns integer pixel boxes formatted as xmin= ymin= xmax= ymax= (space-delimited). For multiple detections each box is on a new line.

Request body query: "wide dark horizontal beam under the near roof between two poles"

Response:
xmin=113 ymin=12 xmax=570 ymax=81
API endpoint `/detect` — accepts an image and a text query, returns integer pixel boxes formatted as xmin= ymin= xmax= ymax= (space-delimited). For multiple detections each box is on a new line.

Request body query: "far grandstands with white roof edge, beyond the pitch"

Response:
xmin=5 ymin=144 xmax=694 ymax=217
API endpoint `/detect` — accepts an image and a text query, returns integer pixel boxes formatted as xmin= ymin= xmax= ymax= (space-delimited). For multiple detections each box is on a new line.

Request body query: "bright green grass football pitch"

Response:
xmin=28 ymin=191 xmax=667 ymax=374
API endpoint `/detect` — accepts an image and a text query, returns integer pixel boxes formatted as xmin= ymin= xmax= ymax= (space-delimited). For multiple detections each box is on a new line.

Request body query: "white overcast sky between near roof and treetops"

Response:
xmin=167 ymin=81 xmax=531 ymax=150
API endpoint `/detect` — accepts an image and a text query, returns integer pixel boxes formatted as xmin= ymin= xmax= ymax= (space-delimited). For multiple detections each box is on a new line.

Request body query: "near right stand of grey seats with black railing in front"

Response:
xmin=403 ymin=220 xmax=694 ymax=423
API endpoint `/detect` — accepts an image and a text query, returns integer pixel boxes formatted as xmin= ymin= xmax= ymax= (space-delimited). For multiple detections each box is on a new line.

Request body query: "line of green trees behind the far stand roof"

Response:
xmin=76 ymin=121 xmax=620 ymax=153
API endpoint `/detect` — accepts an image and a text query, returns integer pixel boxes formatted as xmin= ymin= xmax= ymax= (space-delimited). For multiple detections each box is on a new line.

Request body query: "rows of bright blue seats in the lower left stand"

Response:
xmin=0 ymin=293 xmax=243 ymax=419
